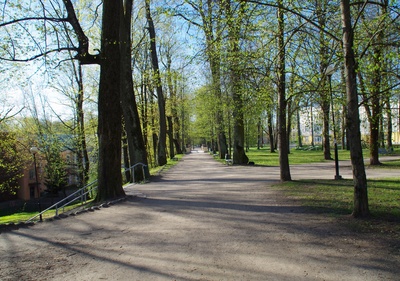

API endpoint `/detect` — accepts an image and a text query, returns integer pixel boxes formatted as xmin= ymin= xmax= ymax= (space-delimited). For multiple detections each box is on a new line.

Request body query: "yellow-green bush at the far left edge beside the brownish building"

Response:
xmin=0 ymin=132 xmax=24 ymax=195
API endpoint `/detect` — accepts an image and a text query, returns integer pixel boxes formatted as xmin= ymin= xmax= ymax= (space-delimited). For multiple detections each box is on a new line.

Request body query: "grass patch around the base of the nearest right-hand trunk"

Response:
xmin=276 ymin=178 xmax=400 ymax=238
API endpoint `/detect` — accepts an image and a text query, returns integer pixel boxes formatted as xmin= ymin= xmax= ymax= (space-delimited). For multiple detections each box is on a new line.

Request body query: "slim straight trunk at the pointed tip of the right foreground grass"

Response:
xmin=278 ymin=0 xmax=292 ymax=181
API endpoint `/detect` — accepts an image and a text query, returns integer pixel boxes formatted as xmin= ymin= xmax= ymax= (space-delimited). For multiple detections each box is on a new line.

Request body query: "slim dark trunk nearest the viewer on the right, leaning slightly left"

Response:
xmin=340 ymin=0 xmax=369 ymax=217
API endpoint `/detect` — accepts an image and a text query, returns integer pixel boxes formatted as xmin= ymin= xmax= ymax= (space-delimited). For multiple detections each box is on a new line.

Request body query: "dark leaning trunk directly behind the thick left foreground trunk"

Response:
xmin=121 ymin=0 xmax=150 ymax=182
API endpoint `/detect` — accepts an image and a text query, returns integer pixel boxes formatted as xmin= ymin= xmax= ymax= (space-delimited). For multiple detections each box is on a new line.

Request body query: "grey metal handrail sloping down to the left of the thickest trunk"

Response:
xmin=26 ymin=180 xmax=97 ymax=222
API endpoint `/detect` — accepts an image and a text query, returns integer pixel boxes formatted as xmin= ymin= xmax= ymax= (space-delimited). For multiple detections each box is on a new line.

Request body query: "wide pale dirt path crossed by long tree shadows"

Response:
xmin=0 ymin=153 xmax=400 ymax=281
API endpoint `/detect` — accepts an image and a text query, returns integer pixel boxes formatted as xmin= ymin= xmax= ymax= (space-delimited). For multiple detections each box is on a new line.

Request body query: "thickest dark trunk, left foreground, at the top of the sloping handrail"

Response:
xmin=96 ymin=0 xmax=125 ymax=201
